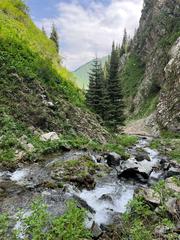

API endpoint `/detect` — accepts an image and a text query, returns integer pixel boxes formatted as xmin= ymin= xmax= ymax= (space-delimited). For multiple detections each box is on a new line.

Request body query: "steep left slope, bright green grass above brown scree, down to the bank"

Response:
xmin=0 ymin=0 xmax=106 ymax=168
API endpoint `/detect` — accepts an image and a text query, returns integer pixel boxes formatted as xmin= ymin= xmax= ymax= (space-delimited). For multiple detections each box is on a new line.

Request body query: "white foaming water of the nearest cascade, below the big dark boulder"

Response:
xmin=79 ymin=182 xmax=135 ymax=226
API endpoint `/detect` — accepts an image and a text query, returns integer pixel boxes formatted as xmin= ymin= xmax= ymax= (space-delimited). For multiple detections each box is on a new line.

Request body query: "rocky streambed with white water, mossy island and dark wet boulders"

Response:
xmin=0 ymin=137 xmax=180 ymax=237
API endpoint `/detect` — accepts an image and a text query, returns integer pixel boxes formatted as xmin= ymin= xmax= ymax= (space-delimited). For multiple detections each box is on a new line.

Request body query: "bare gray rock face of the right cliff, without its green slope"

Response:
xmin=125 ymin=0 xmax=180 ymax=132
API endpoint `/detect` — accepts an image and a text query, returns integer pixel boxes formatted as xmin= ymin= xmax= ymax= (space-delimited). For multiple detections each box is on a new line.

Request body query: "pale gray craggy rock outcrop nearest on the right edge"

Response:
xmin=157 ymin=37 xmax=180 ymax=131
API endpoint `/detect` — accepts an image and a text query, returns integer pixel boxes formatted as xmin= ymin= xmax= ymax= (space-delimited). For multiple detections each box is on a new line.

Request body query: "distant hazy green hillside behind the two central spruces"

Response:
xmin=74 ymin=56 xmax=108 ymax=89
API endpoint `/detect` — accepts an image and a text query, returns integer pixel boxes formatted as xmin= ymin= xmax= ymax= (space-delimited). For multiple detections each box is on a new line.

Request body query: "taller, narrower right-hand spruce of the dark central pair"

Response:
xmin=107 ymin=42 xmax=125 ymax=128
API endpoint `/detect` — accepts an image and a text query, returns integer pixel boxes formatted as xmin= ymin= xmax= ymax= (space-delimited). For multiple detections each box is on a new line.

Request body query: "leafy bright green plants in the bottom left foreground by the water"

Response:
xmin=0 ymin=200 xmax=91 ymax=240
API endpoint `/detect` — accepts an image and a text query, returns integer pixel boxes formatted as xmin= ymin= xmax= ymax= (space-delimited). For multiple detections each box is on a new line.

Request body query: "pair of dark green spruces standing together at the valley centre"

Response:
xmin=86 ymin=42 xmax=125 ymax=130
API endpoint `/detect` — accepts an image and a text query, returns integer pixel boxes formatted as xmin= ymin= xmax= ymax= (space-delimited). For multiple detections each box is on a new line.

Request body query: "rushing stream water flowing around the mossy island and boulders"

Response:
xmin=0 ymin=136 xmax=161 ymax=226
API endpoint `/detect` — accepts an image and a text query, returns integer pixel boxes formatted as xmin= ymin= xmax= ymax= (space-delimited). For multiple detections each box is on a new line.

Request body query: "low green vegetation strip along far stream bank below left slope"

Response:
xmin=0 ymin=111 xmax=138 ymax=167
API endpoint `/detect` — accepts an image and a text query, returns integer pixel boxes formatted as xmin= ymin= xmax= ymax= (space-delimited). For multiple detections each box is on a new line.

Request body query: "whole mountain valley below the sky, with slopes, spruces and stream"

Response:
xmin=0 ymin=0 xmax=180 ymax=240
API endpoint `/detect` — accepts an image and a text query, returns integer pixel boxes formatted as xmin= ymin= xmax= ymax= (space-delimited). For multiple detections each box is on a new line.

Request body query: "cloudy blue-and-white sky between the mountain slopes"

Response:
xmin=26 ymin=0 xmax=143 ymax=71
